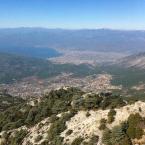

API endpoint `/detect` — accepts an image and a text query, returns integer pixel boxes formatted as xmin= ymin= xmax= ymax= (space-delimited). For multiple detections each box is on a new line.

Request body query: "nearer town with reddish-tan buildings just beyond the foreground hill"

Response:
xmin=0 ymin=74 xmax=121 ymax=99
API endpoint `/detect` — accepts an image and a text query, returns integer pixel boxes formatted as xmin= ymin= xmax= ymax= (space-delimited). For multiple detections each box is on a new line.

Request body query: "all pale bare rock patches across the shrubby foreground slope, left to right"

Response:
xmin=0 ymin=101 xmax=145 ymax=145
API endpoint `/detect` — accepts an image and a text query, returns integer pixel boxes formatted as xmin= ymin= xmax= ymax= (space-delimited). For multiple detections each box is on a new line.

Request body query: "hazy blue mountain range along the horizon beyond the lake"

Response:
xmin=0 ymin=28 xmax=145 ymax=53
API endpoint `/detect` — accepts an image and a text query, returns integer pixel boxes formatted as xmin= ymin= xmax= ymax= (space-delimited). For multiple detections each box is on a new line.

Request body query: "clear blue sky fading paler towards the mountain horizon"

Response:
xmin=0 ymin=0 xmax=145 ymax=30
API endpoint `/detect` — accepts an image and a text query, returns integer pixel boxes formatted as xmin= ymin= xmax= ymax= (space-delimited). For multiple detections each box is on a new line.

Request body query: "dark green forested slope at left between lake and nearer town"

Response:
xmin=0 ymin=53 xmax=93 ymax=83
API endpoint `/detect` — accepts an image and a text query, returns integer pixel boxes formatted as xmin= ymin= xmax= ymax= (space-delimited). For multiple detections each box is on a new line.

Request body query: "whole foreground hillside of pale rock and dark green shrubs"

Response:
xmin=0 ymin=87 xmax=145 ymax=145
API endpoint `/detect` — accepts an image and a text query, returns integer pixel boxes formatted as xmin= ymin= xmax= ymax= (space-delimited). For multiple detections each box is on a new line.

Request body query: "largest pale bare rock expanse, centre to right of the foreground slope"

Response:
xmin=61 ymin=101 xmax=145 ymax=145
